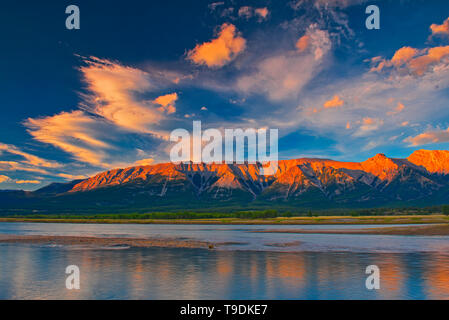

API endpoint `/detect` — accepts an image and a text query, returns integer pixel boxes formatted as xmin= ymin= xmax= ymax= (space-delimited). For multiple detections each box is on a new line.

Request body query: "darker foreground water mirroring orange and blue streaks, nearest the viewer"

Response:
xmin=0 ymin=244 xmax=449 ymax=299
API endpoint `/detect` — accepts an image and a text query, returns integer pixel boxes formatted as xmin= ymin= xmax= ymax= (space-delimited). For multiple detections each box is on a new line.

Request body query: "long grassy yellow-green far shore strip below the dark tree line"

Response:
xmin=0 ymin=215 xmax=449 ymax=225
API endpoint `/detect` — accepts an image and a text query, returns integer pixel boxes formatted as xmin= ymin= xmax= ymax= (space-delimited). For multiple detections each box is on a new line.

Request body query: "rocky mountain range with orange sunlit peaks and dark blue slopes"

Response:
xmin=0 ymin=150 xmax=449 ymax=214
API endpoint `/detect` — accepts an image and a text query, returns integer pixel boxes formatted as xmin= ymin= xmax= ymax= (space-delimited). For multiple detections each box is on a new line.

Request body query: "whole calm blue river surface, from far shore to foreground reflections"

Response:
xmin=0 ymin=223 xmax=449 ymax=299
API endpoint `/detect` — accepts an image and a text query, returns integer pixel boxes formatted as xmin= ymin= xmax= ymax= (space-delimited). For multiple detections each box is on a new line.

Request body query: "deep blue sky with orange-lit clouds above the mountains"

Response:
xmin=0 ymin=0 xmax=449 ymax=190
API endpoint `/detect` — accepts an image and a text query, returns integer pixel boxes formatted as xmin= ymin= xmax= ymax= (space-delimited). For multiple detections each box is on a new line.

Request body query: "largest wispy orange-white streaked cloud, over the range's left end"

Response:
xmin=23 ymin=57 xmax=178 ymax=172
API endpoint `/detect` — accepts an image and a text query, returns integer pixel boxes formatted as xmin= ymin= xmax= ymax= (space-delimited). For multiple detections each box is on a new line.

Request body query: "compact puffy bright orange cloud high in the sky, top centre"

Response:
xmin=187 ymin=23 xmax=246 ymax=68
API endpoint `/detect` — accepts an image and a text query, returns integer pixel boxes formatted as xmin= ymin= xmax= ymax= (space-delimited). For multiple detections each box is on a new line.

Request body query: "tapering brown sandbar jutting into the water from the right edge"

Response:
xmin=252 ymin=224 xmax=449 ymax=236
